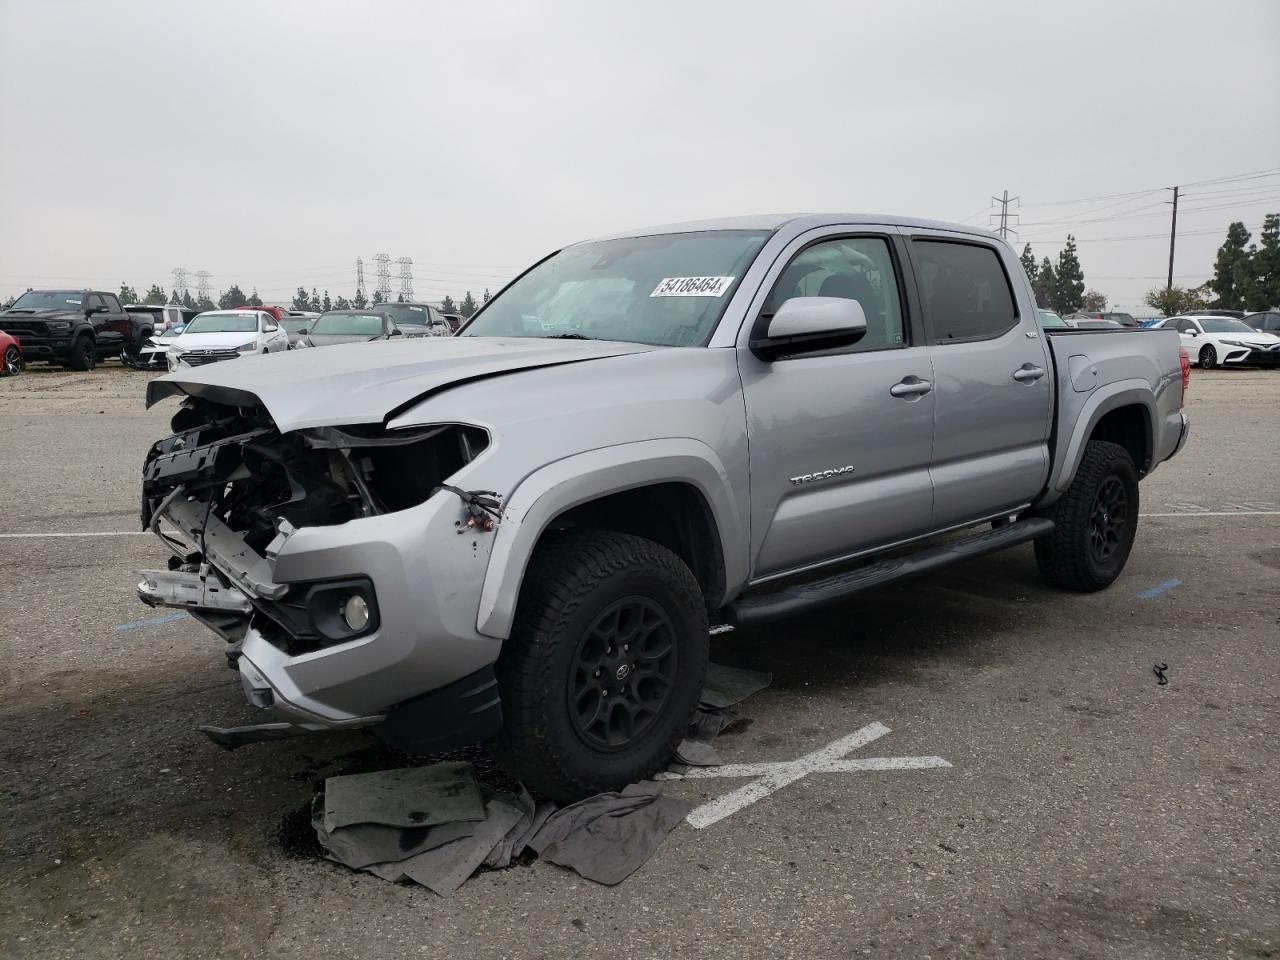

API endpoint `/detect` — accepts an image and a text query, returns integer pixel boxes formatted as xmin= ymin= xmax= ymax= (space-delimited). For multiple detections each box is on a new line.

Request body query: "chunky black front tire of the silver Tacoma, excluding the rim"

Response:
xmin=489 ymin=531 xmax=709 ymax=803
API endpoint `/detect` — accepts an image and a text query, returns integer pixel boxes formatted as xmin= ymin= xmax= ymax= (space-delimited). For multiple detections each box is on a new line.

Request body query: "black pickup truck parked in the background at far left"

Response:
xmin=0 ymin=291 xmax=138 ymax=370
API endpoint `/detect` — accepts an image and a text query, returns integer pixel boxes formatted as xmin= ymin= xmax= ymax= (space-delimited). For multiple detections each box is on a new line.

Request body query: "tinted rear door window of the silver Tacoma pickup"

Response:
xmin=913 ymin=239 xmax=1018 ymax=343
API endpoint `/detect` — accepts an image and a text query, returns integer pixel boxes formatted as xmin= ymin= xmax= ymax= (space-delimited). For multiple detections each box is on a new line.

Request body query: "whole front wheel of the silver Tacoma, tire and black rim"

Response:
xmin=490 ymin=531 xmax=708 ymax=803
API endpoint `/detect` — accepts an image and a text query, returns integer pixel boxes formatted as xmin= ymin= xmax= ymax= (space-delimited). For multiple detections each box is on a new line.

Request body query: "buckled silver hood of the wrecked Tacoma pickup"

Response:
xmin=147 ymin=337 xmax=657 ymax=433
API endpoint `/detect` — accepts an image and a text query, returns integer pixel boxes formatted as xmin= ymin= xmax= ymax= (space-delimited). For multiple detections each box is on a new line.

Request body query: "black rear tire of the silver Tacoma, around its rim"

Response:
xmin=1036 ymin=440 xmax=1138 ymax=593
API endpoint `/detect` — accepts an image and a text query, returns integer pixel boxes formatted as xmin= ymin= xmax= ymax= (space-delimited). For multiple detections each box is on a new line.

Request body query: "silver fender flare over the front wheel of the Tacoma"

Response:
xmin=476 ymin=438 xmax=748 ymax=640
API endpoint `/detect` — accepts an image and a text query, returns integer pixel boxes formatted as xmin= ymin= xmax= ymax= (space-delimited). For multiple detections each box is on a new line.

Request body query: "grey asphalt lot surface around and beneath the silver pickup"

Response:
xmin=0 ymin=364 xmax=1280 ymax=960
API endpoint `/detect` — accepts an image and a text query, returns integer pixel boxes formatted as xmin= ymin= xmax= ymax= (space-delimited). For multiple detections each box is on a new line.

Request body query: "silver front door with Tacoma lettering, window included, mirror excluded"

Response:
xmin=739 ymin=229 xmax=934 ymax=581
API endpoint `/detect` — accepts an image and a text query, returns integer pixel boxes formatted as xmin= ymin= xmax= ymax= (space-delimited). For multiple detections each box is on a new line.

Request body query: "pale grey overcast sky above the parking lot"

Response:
xmin=0 ymin=0 xmax=1280 ymax=307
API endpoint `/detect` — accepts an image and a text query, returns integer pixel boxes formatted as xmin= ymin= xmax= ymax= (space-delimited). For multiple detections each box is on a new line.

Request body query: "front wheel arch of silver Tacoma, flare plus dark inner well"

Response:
xmin=476 ymin=438 xmax=748 ymax=639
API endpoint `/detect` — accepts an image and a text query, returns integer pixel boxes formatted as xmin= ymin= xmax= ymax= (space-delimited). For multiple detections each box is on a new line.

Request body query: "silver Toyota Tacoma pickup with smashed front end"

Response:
xmin=138 ymin=214 xmax=1188 ymax=799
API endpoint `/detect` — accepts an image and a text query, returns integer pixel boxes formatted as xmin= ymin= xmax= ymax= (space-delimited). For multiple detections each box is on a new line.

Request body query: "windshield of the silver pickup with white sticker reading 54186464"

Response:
xmin=458 ymin=230 xmax=768 ymax=347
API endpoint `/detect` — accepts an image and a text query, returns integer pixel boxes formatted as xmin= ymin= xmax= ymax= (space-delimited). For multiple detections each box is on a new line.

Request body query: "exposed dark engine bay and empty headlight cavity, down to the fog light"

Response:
xmin=138 ymin=397 xmax=489 ymax=654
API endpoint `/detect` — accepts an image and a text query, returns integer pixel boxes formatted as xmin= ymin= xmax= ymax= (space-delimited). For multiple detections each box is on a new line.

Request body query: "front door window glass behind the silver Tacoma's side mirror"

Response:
xmin=763 ymin=237 xmax=906 ymax=357
